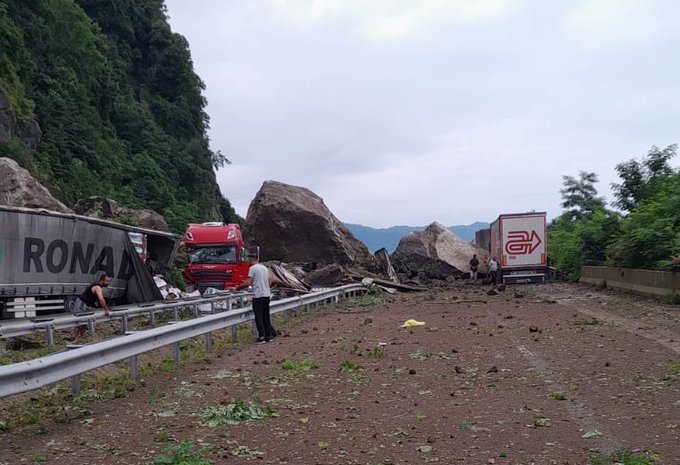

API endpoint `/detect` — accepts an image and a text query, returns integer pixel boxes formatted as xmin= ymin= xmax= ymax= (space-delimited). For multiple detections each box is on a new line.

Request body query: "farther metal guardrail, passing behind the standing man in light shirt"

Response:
xmin=0 ymin=292 xmax=248 ymax=340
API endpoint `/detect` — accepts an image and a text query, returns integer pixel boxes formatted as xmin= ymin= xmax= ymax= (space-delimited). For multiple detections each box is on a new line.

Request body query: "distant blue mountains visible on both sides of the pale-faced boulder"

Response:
xmin=345 ymin=221 xmax=489 ymax=253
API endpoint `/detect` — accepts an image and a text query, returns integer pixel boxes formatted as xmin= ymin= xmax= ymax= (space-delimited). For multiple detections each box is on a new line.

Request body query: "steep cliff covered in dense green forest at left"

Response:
xmin=0 ymin=0 xmax=237 ymax=231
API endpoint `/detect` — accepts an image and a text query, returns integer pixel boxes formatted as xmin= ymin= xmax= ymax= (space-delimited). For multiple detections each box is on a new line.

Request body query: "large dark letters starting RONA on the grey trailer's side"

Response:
xmin=24 ymin=237 xmax=135 ymax=281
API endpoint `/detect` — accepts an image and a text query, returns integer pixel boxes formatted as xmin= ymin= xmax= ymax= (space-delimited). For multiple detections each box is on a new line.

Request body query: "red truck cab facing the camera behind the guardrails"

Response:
xmin=184 ymin=223 xmax=250 ymax=294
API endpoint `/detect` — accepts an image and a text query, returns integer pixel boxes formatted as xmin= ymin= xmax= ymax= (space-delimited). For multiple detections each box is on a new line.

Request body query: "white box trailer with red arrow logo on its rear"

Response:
xmin=490 ymin=212 xmax=548 ymax=284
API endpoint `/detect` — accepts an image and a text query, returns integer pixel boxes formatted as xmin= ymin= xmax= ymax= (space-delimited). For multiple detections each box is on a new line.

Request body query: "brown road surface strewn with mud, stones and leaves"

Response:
xmin=0 ymin=285 xmax=680 ymax=465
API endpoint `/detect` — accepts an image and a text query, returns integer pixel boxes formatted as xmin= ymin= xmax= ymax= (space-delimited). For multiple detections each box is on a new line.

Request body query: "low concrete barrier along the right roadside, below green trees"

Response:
xmin=581 ymin=266 xmax=680 ymax=296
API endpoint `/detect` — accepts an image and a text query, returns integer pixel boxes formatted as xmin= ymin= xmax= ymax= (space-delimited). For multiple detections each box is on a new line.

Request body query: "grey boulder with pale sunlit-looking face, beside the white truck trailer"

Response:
xmin=391 ymin=223 xmax=488 ymax=279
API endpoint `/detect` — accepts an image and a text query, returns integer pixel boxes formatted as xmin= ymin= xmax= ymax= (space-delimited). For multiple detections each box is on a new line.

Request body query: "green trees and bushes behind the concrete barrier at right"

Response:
xmin=548 ymin=145 xmax=680 ymax=280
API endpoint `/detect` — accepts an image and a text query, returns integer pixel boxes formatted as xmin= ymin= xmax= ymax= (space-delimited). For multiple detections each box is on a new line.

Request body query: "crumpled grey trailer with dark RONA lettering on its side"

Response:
xmin=0 ymin=206 xmax=179 ymax=318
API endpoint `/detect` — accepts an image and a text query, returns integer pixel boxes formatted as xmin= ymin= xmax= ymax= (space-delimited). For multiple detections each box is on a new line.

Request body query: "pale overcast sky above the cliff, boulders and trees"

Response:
xmin=166 ymin=0 xmax=680 ymax=227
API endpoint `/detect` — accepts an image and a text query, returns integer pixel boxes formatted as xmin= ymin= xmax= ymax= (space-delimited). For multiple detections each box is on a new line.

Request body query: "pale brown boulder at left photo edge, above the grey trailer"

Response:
xmin=0 ymin=158 xmax=73 ymax=213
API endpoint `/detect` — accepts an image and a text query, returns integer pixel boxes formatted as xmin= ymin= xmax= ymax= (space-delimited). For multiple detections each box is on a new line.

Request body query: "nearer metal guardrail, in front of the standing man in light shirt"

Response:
xmin=0 ymin=284 xmax=365 ymax=398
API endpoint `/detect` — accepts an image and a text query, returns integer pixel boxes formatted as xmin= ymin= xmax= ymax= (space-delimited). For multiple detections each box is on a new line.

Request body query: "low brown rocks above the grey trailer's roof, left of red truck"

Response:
xmin=73 ymin=196 xmax=170 ymax=232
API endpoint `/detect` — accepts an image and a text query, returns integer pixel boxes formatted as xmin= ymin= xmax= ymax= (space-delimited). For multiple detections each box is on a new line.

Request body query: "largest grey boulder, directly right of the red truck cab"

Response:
xmin=244 ymin=181 xmax=371 ymax=265
